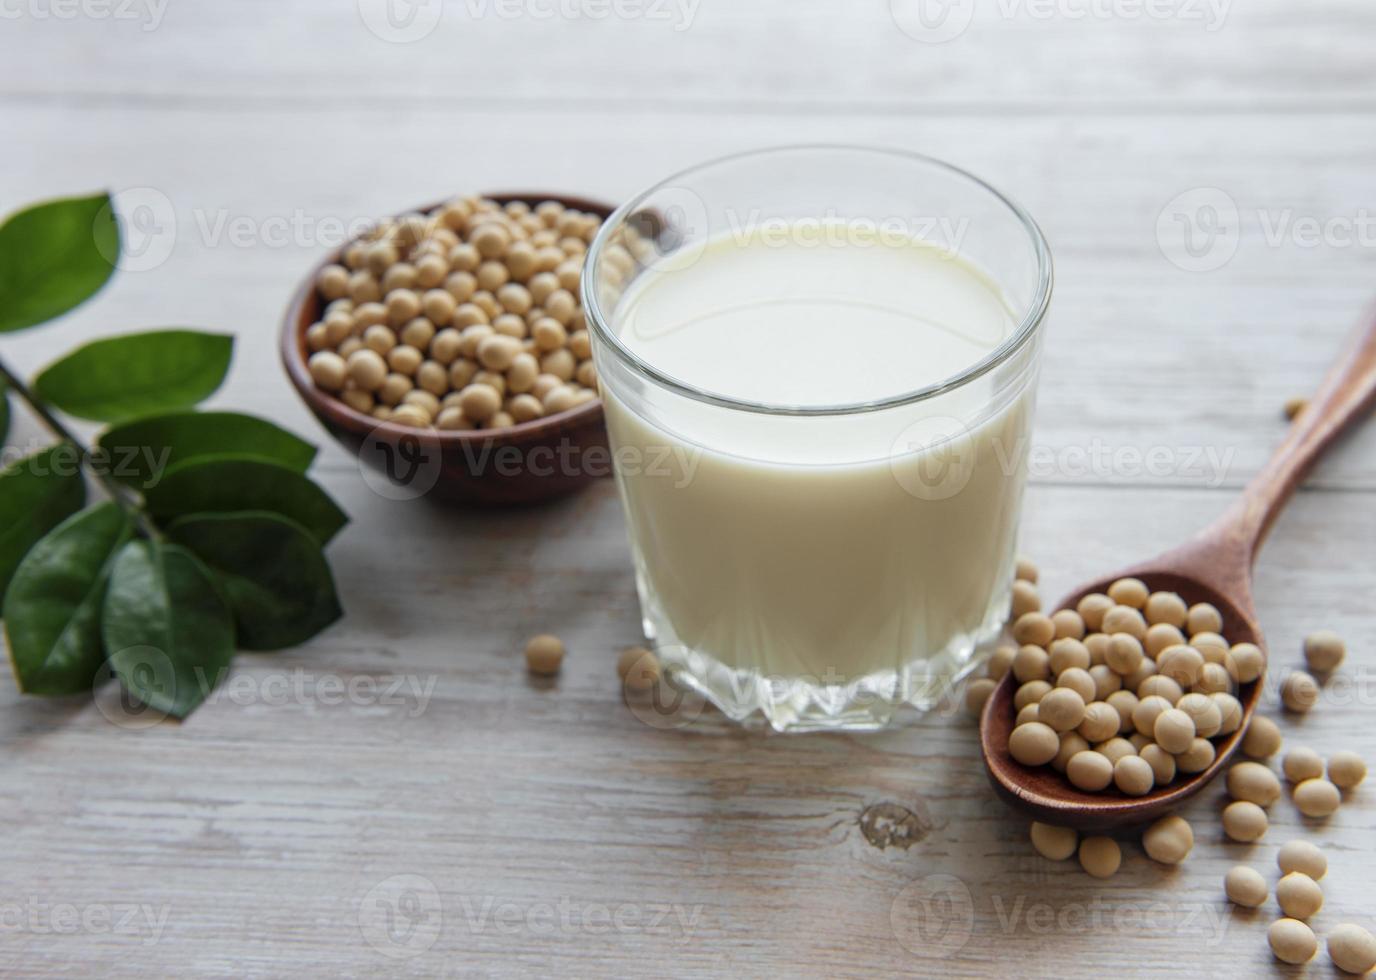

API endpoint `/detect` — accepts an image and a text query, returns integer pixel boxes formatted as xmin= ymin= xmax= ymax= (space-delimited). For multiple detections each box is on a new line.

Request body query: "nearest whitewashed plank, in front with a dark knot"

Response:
xmin=0 ymin=473 xmax=1376 ymax=976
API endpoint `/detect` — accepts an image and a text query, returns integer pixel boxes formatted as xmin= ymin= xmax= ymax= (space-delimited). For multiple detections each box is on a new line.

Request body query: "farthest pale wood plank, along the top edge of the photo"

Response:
xmin=0 ymin=0 xmax=1376 ymax=116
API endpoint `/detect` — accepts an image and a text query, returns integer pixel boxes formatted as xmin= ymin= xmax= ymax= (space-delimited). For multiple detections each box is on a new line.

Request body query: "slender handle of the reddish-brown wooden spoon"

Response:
xmin=1205 ymin=305 xmax=1376 ymax=567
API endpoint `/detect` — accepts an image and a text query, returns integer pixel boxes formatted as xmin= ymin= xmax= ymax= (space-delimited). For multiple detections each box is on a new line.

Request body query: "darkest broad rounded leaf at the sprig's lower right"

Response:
xmin=168 ymin=511 xmax=344 ymax=650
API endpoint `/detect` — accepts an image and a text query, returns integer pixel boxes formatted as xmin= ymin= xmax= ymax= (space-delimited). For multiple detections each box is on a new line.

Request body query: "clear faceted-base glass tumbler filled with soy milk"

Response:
xmin=582 ymin=147 xmax=1051 ymax=731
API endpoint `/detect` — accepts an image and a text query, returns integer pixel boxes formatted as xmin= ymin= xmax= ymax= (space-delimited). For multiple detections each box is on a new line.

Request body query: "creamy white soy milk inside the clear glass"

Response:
xmin=603 ymin=225 xmax=1033 ymax=724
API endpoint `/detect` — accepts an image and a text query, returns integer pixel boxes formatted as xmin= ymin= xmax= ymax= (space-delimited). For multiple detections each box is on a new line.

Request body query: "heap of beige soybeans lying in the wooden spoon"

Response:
xmin=981 ymin=568 xmax=1266 ymax=797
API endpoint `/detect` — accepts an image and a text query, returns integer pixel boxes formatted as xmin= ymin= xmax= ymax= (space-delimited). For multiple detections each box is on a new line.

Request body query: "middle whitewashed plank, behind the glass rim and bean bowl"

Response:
xmin=0 ymin=105 xmax=1376 ymax=489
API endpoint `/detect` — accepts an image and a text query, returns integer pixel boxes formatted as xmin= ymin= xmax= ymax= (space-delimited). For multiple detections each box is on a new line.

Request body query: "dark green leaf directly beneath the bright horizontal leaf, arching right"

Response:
xmin=96 ymin=412 xmax=315 ymax=490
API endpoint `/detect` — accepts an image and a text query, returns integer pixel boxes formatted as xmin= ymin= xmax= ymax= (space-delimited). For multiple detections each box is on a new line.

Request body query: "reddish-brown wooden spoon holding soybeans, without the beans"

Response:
xmin=980 ymin=312 xmax=1376 ymax=830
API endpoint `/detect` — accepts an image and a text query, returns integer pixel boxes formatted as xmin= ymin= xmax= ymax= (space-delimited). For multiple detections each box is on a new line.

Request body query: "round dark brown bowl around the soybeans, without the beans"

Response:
xmin=282 ymin=193 xmax=612 ymax=507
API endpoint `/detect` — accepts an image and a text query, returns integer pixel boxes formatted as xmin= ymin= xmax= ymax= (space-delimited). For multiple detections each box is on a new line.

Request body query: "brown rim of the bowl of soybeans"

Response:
xmin=278 ymin=191 xmax=616 ymax=447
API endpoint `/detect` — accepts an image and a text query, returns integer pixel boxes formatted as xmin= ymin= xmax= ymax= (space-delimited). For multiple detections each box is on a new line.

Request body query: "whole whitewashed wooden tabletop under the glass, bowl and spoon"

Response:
xmin=0 ymin=0 xmax=1376 ymax=976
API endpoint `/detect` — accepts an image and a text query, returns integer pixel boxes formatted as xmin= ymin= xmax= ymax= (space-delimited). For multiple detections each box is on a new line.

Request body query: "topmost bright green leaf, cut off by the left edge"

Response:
xmin=0 ymin=194 xmax=120 ymax=333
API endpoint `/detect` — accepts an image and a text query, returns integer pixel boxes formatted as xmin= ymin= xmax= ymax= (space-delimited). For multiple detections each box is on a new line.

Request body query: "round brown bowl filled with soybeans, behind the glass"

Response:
xmin=282 ymin=194 xmax=611 ymax=504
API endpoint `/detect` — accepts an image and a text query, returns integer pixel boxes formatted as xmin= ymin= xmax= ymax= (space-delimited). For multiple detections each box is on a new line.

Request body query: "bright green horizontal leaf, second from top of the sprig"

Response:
xmin=33 ymin=330 xmax=234 ymax=423
